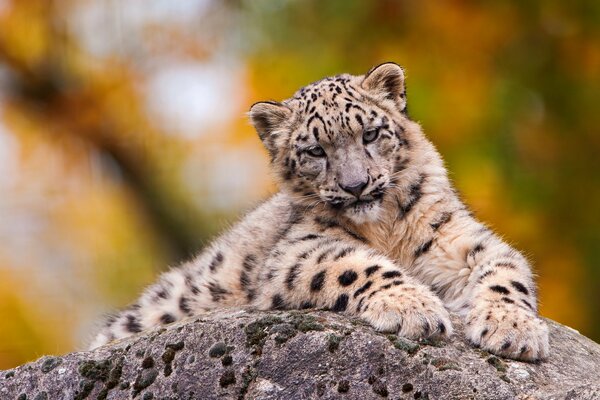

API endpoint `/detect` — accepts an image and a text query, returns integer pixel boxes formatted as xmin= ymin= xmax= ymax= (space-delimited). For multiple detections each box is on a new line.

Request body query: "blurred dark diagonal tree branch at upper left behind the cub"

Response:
xmin=0 ymin=1 xmax=213 ymax=262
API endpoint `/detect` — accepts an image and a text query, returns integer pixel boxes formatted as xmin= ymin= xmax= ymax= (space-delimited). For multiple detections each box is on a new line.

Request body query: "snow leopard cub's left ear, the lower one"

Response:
xmin=248 ymin=101 xmax=292 ymax=155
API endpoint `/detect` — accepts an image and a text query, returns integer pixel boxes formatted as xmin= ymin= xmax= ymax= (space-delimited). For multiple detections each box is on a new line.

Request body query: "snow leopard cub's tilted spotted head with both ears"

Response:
xmin=250 ymin=63 xmax=408 ymax=223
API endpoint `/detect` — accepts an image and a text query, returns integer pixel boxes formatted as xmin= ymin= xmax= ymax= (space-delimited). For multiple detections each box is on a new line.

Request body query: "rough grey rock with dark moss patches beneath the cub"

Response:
xmin=0 ymin=311 xmax=600 ymax=400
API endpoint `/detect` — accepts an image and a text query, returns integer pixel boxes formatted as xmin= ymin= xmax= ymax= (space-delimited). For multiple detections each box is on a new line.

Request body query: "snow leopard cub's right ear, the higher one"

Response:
xmin=361 ymin=62 xmax=407 ymax=114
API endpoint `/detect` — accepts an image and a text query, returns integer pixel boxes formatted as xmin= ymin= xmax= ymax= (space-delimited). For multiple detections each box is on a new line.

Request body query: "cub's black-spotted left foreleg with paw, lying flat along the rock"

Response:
xmin=254 ymin=235 xmax=452 ymax=339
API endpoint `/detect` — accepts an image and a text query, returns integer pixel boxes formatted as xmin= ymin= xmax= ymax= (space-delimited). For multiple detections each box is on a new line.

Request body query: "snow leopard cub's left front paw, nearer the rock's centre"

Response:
xmin=360 ymin=284 xmax=452 ymax=339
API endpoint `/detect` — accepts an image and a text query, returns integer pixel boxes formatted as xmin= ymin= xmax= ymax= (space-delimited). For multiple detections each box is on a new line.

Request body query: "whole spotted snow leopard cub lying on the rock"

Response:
xmin=92 ymin=63 xmax=549 ymax=360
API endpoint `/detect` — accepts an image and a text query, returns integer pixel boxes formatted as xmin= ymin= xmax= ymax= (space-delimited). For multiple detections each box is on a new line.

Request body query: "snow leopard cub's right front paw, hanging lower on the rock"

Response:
xmin=465 ymin=302 xmax=549 ymax=361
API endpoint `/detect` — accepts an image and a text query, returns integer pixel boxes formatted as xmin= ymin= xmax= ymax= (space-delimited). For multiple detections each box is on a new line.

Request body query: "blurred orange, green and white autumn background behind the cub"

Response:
xmin=0 ymin=0 xmax=600 ymax=369
